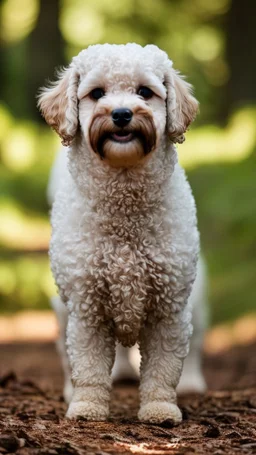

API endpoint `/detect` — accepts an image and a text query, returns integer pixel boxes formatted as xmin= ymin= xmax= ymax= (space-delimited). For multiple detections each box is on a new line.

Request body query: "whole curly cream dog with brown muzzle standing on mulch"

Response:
xmin=39 ymin=44 xmax=204 ymax=423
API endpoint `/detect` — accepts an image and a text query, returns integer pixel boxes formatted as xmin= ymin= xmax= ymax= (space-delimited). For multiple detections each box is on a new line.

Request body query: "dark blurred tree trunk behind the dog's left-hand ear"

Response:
xmin=26 ymin=0 xmax=65 ymax=119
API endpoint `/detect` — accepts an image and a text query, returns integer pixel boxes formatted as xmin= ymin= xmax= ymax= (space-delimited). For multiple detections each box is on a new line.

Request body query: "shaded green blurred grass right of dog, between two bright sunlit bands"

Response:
xmin=189 ymin=153 xmax=256 ymax=323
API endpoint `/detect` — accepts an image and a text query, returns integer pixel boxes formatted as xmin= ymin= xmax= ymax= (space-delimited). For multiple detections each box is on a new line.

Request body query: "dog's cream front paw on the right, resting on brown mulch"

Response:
xmin=138 ymin=401 xmax=182 ymax=425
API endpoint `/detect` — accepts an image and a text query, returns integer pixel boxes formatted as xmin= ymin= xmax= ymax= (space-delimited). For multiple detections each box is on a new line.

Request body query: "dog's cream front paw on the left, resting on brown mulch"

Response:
xmin=66 ymin=401 xmax=109 ymax=421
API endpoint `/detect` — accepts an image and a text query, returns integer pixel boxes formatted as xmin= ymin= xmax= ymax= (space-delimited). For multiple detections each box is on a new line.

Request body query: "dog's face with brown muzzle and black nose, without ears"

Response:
xmin=78 ymin=47 xmax=166 ymax=167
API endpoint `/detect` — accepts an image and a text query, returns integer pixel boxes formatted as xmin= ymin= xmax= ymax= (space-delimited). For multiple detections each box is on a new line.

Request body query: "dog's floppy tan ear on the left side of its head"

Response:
xmin=38 ymin=64 xmax=79 ymax=145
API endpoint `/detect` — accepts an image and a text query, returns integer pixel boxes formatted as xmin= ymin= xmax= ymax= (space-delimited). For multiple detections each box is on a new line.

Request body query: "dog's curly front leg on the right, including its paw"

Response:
xmin=138 ymin=314 xmax=191 ymax=424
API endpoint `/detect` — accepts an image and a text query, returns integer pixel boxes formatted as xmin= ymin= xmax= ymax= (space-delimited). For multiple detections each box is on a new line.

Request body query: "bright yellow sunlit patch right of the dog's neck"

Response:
xmin=179 ymin=108 xmax=256 ymax=169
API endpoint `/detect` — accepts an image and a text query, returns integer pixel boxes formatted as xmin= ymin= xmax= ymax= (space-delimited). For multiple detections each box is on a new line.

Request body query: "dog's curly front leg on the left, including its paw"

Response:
xmin=66 ymin=313 xmax=115 ymax=421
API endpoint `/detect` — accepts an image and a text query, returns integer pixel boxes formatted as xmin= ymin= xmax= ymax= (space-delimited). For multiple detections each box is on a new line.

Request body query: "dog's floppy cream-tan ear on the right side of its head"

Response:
xmin=165 ymin=68 xmax=198 ymax=143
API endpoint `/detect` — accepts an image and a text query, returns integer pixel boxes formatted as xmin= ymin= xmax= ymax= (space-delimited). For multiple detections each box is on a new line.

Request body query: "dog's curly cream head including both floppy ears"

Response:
xmin=39 ymin=44 xmax=198 ymax=167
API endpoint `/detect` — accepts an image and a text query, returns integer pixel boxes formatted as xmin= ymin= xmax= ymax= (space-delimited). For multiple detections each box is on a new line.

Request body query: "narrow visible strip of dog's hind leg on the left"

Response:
xmin=51 ymin=297 xmax=73 ymax=403
